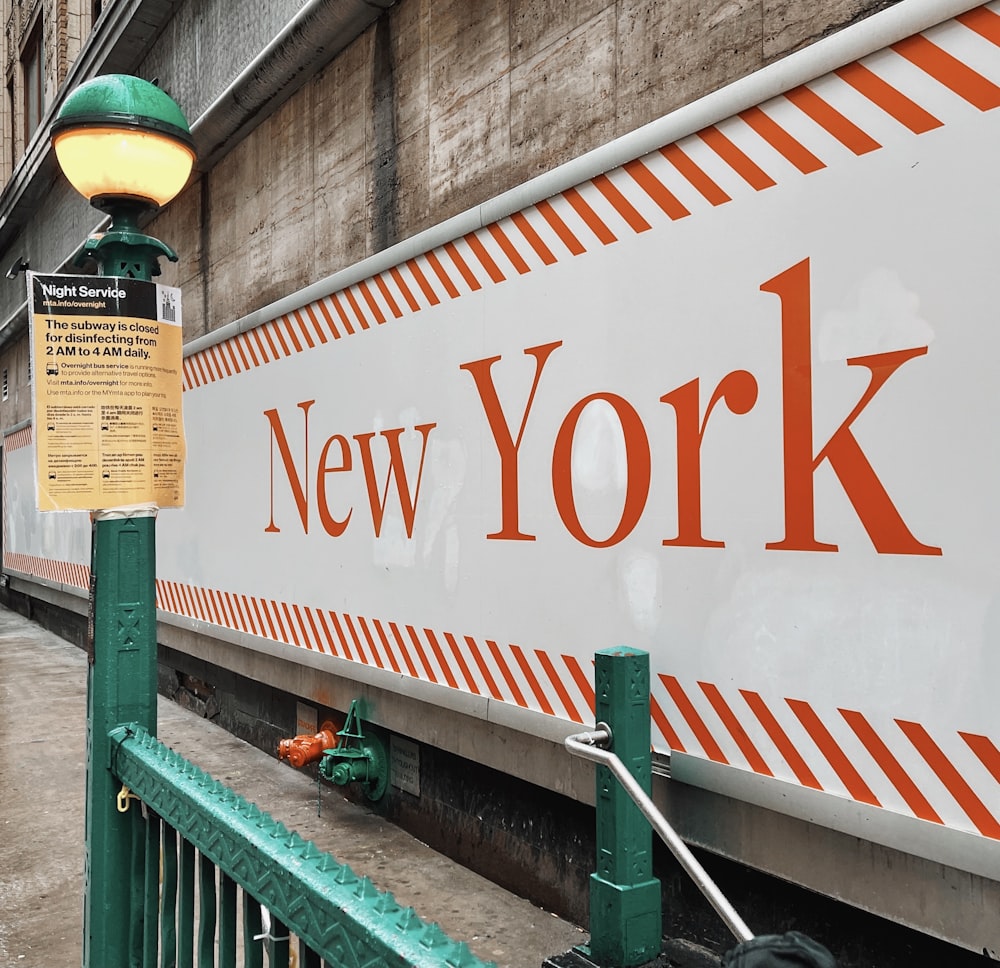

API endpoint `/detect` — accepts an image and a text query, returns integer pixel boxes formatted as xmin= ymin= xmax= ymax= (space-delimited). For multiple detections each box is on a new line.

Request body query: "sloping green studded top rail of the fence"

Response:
xmin=109 ymin=724 xmax=496 ymax=968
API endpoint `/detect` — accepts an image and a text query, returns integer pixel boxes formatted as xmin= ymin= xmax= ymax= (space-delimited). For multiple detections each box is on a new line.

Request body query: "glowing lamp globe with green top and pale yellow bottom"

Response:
xmin=52 ymin=74 xmax=195 ymax=212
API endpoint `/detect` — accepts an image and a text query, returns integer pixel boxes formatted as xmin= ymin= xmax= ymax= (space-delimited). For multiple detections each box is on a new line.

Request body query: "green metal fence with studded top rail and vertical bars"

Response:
xmin=109 ymin=726 xmax=495 ymax=968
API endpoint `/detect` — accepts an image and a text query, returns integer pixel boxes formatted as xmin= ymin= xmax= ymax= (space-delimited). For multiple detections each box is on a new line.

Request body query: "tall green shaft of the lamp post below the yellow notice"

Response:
xmin=83 ymin=233 xmax=158 ymax=968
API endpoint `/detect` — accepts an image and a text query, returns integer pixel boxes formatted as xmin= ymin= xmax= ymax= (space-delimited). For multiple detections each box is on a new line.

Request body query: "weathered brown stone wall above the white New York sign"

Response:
xmin=146 ymin=0 xmax=900 ymax=338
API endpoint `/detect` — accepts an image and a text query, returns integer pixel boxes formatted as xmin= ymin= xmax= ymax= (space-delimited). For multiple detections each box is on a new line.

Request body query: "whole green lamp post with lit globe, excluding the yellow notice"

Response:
xmin=52 ymin=74 xmax=195 ymax=968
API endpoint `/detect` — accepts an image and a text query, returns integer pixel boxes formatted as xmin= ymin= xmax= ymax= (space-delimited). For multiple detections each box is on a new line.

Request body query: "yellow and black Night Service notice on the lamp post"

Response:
xmin=28 ymin=272 xmax=184 ymax=511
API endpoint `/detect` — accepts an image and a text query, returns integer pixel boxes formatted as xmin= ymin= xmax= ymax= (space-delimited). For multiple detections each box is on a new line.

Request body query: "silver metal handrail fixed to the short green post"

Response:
xmin=565 ymin=723 xmax=754 ymax=941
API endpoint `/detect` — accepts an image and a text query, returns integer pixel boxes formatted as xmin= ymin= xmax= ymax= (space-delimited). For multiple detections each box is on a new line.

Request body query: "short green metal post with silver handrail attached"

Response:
xmin=589 ymin=648 xmax=661 ymax=968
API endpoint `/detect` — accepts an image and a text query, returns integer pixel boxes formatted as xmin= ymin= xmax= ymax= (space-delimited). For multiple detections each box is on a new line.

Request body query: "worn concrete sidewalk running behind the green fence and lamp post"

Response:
xmin=0 ymin=608 xmax=587 ymax=968
